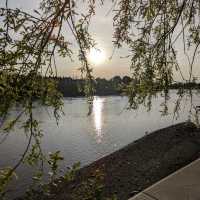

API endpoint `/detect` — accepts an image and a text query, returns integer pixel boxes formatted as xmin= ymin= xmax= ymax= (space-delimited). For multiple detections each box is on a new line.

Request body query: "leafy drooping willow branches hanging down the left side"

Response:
xmin=0 ymin=0 xmax=95 ymax=196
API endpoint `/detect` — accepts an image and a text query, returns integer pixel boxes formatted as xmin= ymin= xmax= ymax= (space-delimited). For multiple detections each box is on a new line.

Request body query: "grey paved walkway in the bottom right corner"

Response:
xmin=129 ymin=159 xmax=200 ymax=200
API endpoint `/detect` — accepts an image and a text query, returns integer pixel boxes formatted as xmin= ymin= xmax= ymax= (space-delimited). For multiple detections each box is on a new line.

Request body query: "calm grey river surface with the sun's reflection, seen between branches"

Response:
xmin=0 ymin=91 xmax=199 ymax=196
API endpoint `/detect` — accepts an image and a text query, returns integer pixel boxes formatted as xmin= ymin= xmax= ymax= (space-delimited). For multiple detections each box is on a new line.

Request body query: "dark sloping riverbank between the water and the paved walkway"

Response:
xmin=18 ymin=123 xmax=200 ymax=200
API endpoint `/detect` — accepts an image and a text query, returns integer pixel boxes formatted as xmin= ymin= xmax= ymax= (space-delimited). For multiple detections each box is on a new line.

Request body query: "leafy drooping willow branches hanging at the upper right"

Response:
xmin=113 ymin=0 xmax=200 ymax=107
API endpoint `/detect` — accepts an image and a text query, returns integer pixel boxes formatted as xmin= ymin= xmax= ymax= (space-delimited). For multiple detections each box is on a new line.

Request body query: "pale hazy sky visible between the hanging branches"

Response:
xmin=0 ymin=0 xmax=200 ymax=80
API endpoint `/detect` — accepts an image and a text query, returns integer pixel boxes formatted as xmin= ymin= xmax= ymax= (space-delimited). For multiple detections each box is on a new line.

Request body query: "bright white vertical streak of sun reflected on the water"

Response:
xmin=92 ymin=97 xmax=105 ymax=143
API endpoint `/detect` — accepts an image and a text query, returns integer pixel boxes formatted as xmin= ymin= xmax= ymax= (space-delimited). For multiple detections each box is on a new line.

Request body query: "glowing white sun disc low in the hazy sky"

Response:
xmin=88 ymin=48 xmax=106 ymax=65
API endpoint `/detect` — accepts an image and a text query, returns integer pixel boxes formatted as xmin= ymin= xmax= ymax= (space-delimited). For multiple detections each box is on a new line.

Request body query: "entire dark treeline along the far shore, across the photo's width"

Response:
xmin=0 ymin=73 xmax=200 ymax=98
